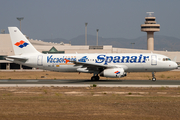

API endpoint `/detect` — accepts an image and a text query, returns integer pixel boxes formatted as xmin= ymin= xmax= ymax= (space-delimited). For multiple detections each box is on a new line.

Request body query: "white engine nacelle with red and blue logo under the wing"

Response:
xmin=100 ymin=68 xmax=126 ymax=78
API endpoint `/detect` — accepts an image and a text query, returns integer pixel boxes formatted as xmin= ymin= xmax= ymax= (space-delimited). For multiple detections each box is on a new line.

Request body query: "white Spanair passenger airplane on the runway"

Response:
xmin=6 ymin=27 xmax=178 ymax=81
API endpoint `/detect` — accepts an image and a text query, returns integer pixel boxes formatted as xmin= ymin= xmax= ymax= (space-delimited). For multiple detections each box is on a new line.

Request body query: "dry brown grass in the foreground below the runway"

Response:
xmin=0 ymin=87 xmax=180 ymax=120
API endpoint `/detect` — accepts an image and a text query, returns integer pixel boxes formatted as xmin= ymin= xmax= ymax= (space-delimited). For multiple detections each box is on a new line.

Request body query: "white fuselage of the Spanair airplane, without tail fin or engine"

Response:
xmin=14 ymin=53 xmax=177 ymax=72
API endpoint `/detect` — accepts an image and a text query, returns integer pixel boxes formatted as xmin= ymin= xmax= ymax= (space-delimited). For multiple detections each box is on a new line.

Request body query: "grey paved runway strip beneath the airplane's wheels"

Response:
xmin=0 ymin=80 xmax=180 ymax=87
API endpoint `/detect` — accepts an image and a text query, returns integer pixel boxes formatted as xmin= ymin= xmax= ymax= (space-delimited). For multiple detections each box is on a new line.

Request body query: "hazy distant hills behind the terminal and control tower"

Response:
xmin=43 ymin=35 xmax=180 ymax=51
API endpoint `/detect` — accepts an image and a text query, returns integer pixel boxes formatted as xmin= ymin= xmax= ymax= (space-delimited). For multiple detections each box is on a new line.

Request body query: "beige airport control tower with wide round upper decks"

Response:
xmin=141 ymin=12 xmax=160 ymax=51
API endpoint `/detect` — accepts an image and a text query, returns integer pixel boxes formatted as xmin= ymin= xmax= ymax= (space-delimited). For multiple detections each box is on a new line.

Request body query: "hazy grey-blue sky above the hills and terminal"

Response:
xmin=0 ymin=0 xmax=180 ymax=40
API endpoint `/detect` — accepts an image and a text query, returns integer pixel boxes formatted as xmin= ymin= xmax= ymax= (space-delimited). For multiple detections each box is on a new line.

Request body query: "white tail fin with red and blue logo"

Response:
xmin=8 ymin=27 xmax=39 ymax=55
